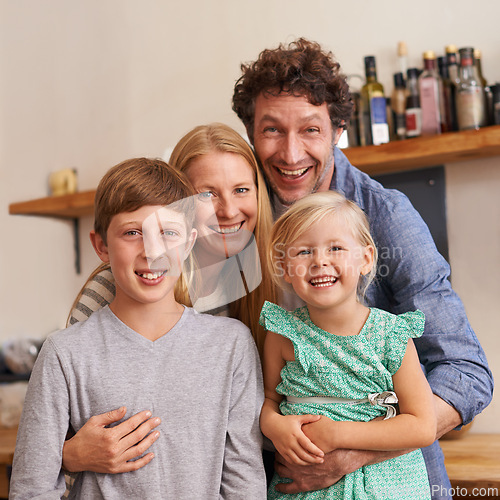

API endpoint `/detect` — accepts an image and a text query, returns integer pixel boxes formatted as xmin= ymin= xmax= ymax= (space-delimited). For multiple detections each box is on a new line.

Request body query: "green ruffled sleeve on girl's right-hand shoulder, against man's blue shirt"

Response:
xmin=385 ymin=310 xmax=425 ymax=375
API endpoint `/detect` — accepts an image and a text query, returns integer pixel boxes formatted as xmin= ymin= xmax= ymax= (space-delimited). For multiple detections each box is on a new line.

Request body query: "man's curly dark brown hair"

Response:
xmin=233 ymin=38 xmax=353 ymax=140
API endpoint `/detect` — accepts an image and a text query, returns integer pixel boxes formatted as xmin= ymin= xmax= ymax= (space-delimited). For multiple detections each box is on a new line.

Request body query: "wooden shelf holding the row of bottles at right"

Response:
xmin=344 ymin=125 xmax=500 ymax=175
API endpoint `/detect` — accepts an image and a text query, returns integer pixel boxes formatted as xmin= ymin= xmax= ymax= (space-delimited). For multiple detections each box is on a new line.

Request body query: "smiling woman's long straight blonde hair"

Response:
xmin=169 ymin=123 xmax=277 ymax=355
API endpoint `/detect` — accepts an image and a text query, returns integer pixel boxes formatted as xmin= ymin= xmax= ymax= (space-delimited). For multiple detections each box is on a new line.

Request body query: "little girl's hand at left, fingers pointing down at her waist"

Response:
xmin=268 ymin=415 xmax=324 ymax=465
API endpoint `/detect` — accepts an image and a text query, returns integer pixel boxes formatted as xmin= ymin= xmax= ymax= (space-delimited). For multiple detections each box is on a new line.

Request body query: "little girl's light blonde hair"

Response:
xmin=267 ymin=191 xmax=377 ymax=301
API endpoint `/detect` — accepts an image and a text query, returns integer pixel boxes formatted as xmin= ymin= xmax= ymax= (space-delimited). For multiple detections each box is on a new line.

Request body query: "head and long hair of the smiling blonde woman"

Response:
xmin=170 ymin=123 xmax=276 ymax=353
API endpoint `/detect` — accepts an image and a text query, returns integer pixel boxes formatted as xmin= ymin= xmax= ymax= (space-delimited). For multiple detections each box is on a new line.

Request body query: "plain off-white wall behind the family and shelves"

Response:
xmin=0 ymin=0 xmax=500 ymax=432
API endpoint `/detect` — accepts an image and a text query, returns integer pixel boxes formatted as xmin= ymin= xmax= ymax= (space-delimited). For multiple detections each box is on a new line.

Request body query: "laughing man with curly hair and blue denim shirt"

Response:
xmin=233 ymin=39 xmax=493 ymax=498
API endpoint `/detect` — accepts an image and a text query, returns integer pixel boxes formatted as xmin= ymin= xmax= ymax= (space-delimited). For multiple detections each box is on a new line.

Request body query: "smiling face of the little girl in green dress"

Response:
xmin=284 ymin=214 xmax=373 ymax=310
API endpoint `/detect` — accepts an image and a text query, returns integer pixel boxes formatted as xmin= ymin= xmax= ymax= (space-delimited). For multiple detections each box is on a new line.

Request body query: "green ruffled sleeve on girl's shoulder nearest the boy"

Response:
xmin=259 ymin=300 xmax=311 ymax=373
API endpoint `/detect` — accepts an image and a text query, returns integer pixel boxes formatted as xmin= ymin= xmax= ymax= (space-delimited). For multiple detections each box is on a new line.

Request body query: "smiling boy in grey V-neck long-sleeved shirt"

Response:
xmin=10 ymin=158 xmax=266 ymax=500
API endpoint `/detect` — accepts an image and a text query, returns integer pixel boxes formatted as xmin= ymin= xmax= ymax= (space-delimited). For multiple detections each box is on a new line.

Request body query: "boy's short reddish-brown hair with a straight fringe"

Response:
xmin=94 ymin=158 xmax=195 ymax=244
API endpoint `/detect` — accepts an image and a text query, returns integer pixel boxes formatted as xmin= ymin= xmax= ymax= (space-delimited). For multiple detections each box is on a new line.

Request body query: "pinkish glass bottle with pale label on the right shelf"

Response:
xmin=418 ymin=50 xmax=444 ymax=135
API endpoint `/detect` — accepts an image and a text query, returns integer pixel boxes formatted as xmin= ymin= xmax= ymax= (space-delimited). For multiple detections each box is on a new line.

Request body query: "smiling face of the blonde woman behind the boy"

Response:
xmin=186 ymin=151 xmax=257 ymax=263
